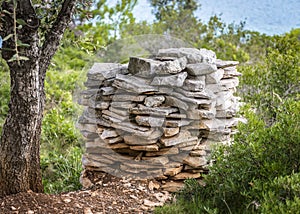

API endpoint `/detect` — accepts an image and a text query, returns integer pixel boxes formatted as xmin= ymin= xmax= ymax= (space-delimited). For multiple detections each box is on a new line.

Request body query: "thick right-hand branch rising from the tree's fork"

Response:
xmin=40 ymin=0 xmax=77 ymax=76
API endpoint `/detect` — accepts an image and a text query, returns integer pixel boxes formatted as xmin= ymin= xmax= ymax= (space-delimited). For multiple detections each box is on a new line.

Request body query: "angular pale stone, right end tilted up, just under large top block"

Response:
xmin=150 ymin=72 xmax=187 ymax=87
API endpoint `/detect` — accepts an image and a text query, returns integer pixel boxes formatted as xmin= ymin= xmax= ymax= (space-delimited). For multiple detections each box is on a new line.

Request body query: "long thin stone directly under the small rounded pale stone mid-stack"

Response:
xmin=130 ymin=104 xmax=178 ymax=116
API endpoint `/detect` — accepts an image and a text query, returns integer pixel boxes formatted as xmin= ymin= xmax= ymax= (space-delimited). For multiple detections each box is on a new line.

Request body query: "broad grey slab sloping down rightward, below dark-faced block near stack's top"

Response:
xmin=113 ymin=74 xmax=158 ymax=94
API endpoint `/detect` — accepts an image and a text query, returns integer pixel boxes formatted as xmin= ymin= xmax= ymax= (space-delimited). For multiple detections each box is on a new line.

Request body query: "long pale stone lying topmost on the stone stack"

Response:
xmin=157 ymin=48 xmax=203 ymax=63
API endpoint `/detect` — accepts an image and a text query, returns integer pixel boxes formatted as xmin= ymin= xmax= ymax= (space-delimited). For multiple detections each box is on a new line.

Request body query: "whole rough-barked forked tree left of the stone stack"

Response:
xmin=0 ymin=0 xmax=76 ymax=197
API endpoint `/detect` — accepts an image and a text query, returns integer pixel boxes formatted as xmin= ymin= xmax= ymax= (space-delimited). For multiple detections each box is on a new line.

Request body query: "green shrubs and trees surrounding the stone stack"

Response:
xmin=0 ymin=0 xmax=300 ymax=213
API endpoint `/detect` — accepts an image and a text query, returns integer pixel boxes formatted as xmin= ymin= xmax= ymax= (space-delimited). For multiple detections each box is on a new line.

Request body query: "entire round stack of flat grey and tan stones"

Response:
xmin=79 ymin=48 xmax=240 ymax=190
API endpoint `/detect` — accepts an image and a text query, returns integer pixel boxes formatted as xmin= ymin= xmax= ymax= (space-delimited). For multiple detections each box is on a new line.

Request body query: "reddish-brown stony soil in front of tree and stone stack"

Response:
xmin=0 ymin=173 xmax=172 ymax=214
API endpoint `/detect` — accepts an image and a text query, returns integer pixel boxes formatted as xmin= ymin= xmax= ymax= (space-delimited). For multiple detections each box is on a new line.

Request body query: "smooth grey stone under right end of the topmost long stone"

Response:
xmin=186 ymin=62 xmax=217 ymax=76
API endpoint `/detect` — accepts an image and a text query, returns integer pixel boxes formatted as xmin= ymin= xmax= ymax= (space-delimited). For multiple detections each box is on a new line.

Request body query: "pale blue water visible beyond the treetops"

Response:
xmin=134 ymin=0 xmax=300 ymax=35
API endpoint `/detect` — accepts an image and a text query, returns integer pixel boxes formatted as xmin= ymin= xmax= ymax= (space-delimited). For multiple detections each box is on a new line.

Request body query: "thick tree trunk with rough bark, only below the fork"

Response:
xmin=0 ymin=57 xmax=45 ymax=196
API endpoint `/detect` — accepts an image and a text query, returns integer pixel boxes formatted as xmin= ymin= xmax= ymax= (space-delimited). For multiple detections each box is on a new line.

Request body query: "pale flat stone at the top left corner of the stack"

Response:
xmin=87 ymin=63 xmax=126 ymax=80
